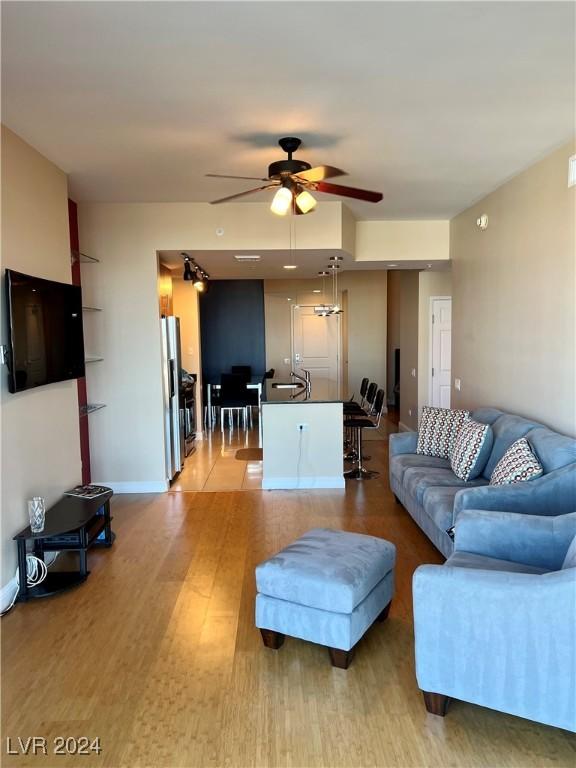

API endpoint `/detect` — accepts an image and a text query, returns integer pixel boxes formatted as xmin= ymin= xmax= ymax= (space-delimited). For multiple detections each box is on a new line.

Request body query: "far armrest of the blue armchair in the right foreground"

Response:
xmin=454 ymin=510 xmax=576 ymax=571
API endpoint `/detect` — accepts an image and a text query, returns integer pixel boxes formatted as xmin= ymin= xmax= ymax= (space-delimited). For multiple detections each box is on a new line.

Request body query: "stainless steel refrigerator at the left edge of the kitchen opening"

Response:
xmin=162 ymin=317 xmax=185 ymax=482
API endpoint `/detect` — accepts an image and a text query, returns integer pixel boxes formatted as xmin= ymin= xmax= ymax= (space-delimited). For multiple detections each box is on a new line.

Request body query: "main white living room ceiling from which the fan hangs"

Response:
xmin=2 ymin=2 xmax=574 ymax=219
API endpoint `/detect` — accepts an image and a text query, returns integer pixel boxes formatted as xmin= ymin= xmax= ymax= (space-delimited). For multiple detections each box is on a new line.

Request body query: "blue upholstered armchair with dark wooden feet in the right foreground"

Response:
xmin=414 ymin=510 xmax=576 ymax=731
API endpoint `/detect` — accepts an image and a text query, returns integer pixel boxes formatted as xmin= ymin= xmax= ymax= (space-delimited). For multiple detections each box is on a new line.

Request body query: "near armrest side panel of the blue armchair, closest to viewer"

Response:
xmin=413 ymin=565 xmax=576 ymax=730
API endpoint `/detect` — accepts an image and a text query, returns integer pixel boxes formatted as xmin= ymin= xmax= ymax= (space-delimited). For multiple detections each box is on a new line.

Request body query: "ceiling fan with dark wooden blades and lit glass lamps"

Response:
xmin=206 ymin=136 xmax=382 ymax=216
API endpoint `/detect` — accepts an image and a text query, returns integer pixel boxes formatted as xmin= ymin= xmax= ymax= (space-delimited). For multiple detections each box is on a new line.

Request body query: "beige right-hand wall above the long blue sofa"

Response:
xmin=450 ymin=145 xmax=576 ymax=434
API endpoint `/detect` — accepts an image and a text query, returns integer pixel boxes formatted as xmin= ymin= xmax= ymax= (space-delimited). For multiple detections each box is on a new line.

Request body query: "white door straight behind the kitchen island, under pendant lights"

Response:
xmin=292 ymin=305 xmax=340 ymax=386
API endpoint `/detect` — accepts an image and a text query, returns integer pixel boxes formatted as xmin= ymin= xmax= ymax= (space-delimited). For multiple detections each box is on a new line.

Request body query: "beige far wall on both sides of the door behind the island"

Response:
xmin=264 ymin=270 xmax=387 ymax=394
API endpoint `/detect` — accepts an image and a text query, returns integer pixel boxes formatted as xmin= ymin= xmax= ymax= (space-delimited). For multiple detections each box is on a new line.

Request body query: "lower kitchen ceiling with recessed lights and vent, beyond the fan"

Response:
xmin=159 ymin=250 xmax=450 ymax=281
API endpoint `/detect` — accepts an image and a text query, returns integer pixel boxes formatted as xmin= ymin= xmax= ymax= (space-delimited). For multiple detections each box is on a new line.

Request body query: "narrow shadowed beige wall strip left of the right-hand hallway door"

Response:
xmin=400 ymin=270 xmax=419 ymax=429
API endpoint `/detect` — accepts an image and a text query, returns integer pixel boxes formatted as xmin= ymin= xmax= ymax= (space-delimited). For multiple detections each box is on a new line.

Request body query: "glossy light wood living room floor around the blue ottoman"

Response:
xmin=1 ymin=420 xmax=576 ymax=768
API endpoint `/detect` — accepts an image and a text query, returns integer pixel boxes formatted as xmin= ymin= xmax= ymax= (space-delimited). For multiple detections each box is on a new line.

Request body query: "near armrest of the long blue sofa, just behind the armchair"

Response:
xmin=453 ymin=464 xmax=576 ymax=523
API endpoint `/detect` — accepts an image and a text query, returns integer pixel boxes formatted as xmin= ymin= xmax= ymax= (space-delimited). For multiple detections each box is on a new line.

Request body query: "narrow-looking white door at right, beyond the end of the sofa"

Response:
xmin=430 ymin=297 xmax=452 ymax=408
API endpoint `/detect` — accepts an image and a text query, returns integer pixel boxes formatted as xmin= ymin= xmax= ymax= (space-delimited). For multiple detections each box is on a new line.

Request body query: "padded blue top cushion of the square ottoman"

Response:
xmin=256 ymin=528 xmax=396 ymax=613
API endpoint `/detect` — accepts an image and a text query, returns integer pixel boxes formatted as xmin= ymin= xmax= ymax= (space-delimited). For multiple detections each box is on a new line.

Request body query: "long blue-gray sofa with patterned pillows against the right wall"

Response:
xmin=389 ymin=408 xmax=576 ymax=557
